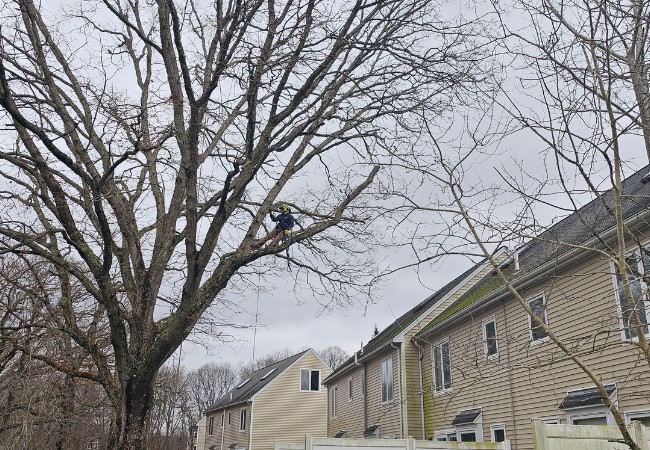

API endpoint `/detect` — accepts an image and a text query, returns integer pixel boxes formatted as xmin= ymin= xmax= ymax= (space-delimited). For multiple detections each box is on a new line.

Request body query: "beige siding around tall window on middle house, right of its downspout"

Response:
xmin=366 ymin=347 xmax=402 ymax=438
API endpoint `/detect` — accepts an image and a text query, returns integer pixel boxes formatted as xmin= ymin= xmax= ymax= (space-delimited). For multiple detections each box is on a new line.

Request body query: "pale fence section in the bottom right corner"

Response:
xmin=533 ymin=419 xmax=650 ymax=450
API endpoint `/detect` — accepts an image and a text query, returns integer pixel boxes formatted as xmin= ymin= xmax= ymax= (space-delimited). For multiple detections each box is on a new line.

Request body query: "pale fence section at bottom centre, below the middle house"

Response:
xmin=275 ymin=435 xmax=510 ymax=450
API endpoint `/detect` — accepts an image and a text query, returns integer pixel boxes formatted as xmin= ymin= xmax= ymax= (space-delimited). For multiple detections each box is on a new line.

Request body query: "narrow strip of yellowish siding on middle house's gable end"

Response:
xmin=403 ymin=260 xmax=506 ymax=439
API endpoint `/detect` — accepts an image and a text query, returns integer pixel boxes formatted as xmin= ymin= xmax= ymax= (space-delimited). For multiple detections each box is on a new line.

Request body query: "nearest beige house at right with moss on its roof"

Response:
xmin=413 ymin=167 xmax=650 ymax=450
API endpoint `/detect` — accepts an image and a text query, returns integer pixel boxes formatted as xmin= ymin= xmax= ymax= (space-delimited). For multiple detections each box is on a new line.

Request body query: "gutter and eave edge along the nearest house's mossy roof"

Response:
xmin=411 ymin=209 xmax=650 ymax=342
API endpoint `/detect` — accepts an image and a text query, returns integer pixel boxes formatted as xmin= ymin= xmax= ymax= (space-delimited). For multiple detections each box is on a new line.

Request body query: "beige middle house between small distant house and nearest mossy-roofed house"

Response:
xmin=324 ymin=249 xmax=507 ymax=439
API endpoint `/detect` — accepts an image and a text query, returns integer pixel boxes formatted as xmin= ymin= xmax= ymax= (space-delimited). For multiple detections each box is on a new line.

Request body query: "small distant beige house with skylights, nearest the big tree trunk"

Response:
xmin=202 ymin=349 xmax=331 ymax=450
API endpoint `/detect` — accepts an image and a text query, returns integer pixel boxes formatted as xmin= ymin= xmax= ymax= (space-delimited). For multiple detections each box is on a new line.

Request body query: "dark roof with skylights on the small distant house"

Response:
xmin=206 ymin=349 xmax=312 ymax=413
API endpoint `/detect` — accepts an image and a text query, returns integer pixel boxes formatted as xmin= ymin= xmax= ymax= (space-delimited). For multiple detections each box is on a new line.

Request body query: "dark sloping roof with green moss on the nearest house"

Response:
xmin=415 ymin=165 xmax=650 ymax=340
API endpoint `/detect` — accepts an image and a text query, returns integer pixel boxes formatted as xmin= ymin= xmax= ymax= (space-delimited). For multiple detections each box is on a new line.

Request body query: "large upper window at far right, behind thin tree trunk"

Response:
xmin=612 ymin=247 xmax=650 ymax=340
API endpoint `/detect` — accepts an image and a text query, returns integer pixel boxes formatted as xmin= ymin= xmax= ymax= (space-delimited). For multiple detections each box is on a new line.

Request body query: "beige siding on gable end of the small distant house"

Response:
xmin=251 ymin=351 xmax=331 ymax=450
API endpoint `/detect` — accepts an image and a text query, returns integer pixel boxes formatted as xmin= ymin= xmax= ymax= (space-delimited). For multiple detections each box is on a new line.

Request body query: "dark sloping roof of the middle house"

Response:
xmin=323 ymin=253 xmax=505 ymax=384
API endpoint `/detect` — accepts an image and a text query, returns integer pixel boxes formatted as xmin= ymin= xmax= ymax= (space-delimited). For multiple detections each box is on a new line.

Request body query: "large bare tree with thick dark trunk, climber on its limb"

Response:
xmin=0 ymin=0 xmax=485 ymax=449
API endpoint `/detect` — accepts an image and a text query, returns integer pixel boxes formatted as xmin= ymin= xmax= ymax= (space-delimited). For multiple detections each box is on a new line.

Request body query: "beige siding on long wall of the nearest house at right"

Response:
xmin=423 ymin=251 xmax=650 ymax=450
